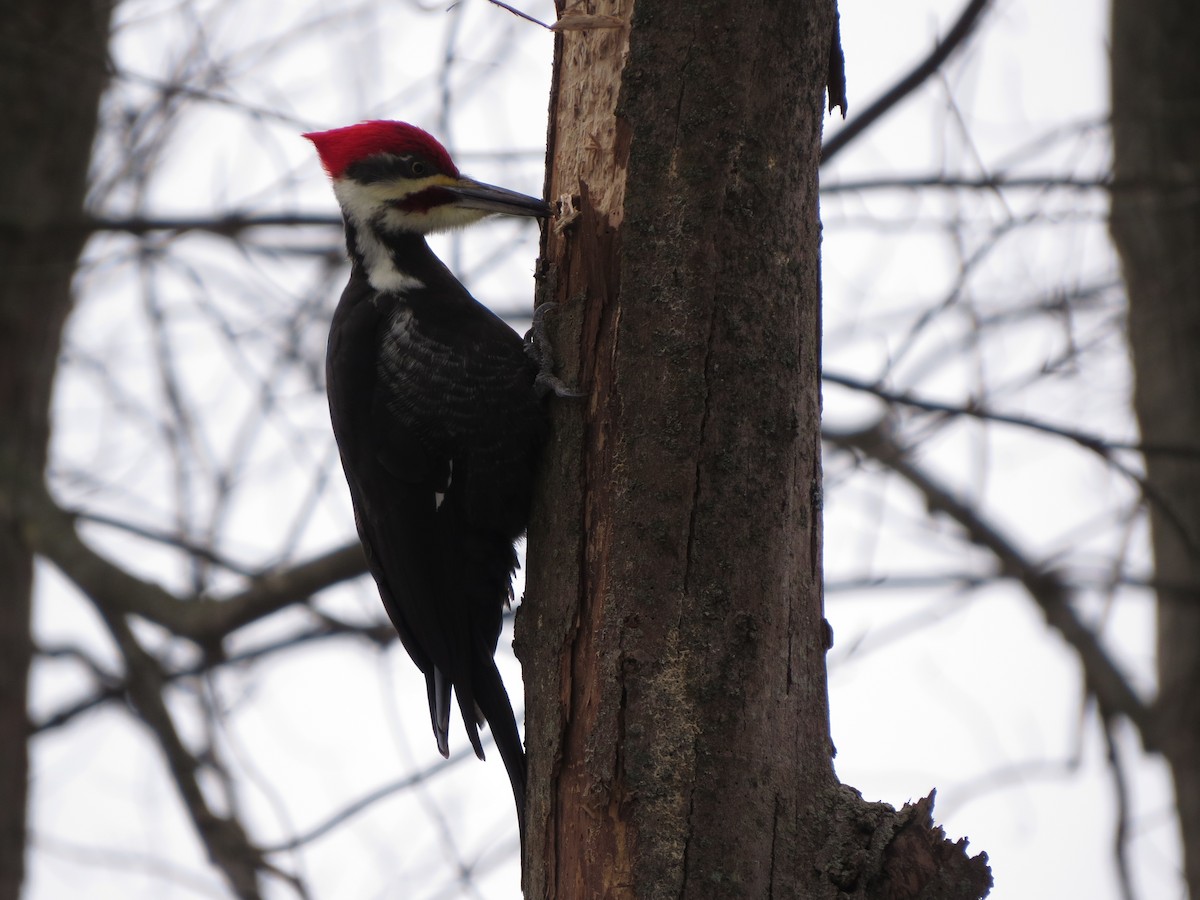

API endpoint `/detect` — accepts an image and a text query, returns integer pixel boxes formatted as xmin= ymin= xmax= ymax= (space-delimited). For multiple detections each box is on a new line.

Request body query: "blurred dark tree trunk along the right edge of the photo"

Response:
xmin=1112 ymin=0 xmax=1200 ymax=898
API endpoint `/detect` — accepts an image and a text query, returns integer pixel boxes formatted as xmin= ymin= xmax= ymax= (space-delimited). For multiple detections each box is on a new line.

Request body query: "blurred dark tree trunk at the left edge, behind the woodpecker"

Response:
xmin=0 ymin=0 xmax=112 ymax=900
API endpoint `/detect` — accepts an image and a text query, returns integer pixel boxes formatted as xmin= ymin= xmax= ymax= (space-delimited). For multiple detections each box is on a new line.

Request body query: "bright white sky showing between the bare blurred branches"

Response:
xmin=26 ymin=0 xmax=1182 ymax=900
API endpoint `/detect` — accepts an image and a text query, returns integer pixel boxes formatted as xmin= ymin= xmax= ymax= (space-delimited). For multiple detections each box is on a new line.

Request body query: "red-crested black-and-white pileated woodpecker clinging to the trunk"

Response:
xmin=305 ymin=121 xmax=556 ymax=841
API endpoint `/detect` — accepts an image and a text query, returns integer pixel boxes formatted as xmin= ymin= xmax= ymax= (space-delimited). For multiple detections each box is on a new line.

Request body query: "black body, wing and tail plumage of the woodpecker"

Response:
xmin=326 ymin=234 xmax=545 ymax=840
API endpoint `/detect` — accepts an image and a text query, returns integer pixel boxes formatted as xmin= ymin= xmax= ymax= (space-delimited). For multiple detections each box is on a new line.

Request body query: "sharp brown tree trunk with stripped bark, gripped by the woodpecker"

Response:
xmin=516 ymin=0 xmax=988 ymax=900
